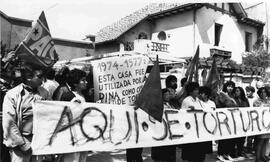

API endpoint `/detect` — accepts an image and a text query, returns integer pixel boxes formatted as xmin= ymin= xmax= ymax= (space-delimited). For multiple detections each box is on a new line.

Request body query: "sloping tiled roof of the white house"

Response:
xmin=96 ymin=3 xmax=183 ymax=43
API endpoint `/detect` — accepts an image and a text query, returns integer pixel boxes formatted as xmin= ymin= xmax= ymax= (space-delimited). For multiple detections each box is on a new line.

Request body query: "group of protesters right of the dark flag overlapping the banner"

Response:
xmin=152 ymin=75 xmax=270 ymax=162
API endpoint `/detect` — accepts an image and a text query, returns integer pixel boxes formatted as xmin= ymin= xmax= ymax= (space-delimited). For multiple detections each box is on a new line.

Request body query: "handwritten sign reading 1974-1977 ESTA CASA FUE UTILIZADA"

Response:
xmin=92 ymin=55 xmax=149 ymax=105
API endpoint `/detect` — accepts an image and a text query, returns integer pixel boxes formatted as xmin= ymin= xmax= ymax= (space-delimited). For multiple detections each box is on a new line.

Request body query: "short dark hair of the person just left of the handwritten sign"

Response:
xmin=67 ymin=69 xmax=86 ymax=90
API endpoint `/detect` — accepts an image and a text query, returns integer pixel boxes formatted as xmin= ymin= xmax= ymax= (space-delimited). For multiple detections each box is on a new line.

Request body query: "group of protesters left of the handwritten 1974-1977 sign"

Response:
xmin=0 ymin=52 xmax=93 ymax=162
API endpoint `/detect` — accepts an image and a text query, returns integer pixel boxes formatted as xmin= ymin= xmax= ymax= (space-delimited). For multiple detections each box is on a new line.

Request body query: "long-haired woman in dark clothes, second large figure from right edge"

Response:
xmin=232 ymin=87 xmax=249 ymax=160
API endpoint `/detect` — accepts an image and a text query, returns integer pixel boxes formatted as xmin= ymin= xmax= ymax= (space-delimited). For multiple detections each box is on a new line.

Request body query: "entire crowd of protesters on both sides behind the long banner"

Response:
xmin=0 ymin=52 xmax=270 ymax=162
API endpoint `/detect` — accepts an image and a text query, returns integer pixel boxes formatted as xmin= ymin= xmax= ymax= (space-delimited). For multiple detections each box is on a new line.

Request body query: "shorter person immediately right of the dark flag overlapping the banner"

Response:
xmin=151 ymin=88 xmax=176 ymax=162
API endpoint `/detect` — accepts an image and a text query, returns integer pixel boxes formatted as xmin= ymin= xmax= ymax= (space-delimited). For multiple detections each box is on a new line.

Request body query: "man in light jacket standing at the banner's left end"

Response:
xmin=2 ymin=65 xmax=47 ymax=162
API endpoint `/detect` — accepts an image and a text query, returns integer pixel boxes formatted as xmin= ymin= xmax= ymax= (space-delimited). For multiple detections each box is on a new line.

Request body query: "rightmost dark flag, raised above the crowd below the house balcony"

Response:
xmin=205 ymin=58 xmax=220 ymax=93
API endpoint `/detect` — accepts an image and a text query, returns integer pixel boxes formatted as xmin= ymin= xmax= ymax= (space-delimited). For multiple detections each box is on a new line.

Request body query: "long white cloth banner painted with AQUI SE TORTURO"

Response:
xmin=32 ymin=101 xmax=270 ymax=155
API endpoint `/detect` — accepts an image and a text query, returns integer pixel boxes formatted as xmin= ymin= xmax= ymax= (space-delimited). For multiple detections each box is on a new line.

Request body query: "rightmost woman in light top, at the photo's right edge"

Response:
xmin=253 ymin=87 xmax=270 ymax=162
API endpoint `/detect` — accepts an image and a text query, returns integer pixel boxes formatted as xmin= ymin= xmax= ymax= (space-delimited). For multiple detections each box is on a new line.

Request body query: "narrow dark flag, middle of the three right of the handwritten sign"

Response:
xmin=176 ymin=46 xmax=200 ymax=106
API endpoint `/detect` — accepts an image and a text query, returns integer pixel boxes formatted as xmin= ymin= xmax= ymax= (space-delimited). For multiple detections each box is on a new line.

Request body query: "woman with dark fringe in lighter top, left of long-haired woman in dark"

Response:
xmin=216 ymin=81 xmax=237 ymax=161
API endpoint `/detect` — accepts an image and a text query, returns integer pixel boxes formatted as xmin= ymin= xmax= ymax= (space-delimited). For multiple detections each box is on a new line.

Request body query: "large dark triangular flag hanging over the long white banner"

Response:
xmin=135 ymin=56 xmax=164 ymax=122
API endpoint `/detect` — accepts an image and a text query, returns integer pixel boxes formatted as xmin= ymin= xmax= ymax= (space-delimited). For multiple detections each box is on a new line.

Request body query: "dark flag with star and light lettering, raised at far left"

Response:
xmin=15 ymin=11 xmax=58 ymax=68
